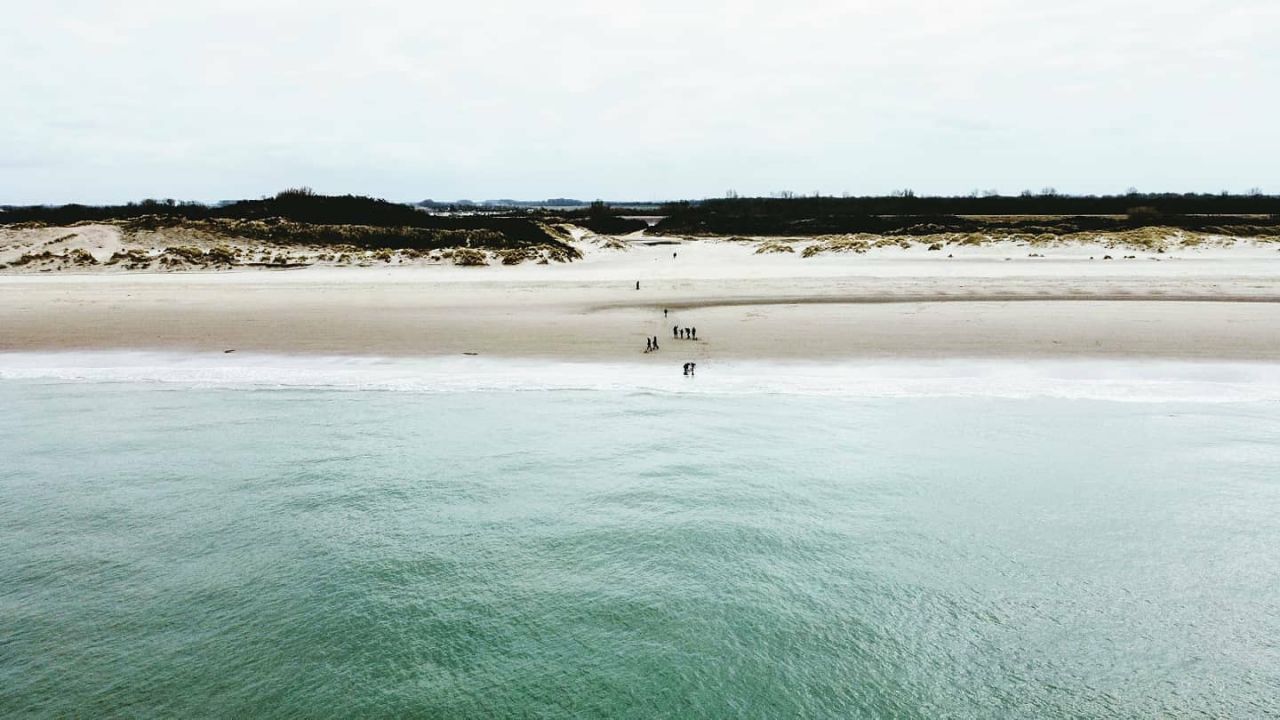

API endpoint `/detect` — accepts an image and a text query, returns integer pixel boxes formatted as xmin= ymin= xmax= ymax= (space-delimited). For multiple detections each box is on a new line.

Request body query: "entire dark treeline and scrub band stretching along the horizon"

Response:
xmin=10 ymin=188 xmax=1280 ymax=238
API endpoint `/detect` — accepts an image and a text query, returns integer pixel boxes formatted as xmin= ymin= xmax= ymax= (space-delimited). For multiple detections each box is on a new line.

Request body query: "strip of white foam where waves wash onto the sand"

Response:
xmin=0 ymin=352 xmax=1280 ymax=402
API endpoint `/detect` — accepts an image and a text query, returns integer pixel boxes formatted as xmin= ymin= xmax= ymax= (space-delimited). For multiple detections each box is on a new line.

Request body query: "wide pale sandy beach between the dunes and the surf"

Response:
xmin=0 ymin=234 xmax=1280 ymax=364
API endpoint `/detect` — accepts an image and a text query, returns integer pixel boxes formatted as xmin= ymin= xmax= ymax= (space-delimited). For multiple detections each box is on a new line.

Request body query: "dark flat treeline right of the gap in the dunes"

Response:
xmin=653 ymin=193 xmax=1280 ymax=234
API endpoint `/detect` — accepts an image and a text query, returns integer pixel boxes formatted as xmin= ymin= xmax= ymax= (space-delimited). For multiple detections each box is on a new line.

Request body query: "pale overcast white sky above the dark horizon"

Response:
xmin=0 ymin=0 xmax=1280 ymax=204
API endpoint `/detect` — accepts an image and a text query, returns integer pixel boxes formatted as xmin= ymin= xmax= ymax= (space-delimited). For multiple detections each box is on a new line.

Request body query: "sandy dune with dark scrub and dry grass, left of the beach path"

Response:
xmin=0 ymin=191 xmax=593 ymax=272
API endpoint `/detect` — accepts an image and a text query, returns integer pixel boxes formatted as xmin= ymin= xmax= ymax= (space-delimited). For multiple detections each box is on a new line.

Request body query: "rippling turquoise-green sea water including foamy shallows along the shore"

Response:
xmin=0 ymin=356 xmax=1280 ymax=717
